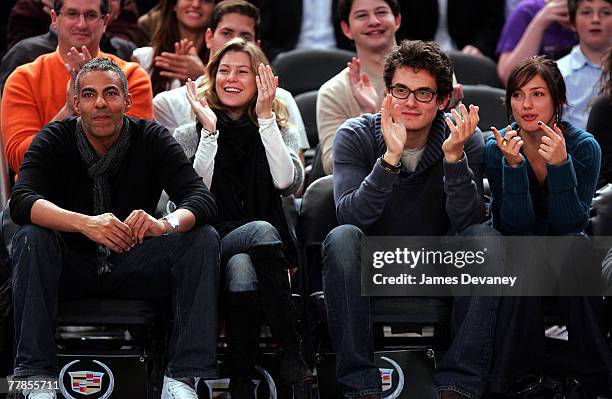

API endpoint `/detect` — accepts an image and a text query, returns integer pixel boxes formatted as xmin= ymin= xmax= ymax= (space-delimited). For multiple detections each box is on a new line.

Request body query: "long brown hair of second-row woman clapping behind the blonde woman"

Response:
xmin=148 ymin=0 xmax=215 ymax=95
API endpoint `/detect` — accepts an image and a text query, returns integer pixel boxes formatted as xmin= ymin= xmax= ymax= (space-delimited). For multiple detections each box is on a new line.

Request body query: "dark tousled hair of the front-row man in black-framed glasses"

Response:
xmin=383 ymin=40 xmax=453 ymax=100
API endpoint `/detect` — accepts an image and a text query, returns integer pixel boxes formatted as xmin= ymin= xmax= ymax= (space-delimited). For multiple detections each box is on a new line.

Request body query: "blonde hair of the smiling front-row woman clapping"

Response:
xmin=197 ymin=38 xmax=289 ymax=128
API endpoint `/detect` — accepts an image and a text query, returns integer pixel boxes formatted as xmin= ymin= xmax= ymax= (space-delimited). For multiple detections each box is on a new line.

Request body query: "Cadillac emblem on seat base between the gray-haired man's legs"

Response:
xmin=59 ymin=360 xmax=115 ymax=399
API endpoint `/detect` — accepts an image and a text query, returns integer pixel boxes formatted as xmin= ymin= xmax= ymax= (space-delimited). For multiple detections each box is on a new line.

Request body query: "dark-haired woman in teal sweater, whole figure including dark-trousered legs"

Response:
xmin=485 ymin=56 xmax=612 ymax=398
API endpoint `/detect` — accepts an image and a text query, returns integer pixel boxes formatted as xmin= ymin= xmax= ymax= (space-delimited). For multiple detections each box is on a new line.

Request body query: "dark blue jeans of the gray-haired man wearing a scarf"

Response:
xmin=12 ymin=225 xmax=220 ymax=378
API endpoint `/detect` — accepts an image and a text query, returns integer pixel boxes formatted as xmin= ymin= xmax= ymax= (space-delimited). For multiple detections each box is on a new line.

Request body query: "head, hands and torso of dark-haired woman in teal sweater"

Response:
xmin=485 ymin=57 xmax=601 ymax=235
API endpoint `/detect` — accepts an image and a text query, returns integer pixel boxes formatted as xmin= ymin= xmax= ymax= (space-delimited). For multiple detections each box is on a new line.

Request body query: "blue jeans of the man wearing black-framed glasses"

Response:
xmin=322 ymin=225 xmax=499 ymax=398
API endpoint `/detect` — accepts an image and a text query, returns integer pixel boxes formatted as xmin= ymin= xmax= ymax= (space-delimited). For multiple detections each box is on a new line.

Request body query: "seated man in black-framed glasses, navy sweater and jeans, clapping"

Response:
xmin=322 ymin=41 xmax=499 ymax=399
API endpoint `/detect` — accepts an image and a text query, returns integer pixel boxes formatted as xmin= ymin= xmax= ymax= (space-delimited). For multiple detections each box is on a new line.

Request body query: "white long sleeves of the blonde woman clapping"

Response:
xmin=174 ymin=113 xmax=304 ymax=195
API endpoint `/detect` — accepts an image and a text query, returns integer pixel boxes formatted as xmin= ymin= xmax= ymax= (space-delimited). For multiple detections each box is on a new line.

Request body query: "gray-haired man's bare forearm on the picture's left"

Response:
xmin=30 ymin=199 xmax=89 ymax=233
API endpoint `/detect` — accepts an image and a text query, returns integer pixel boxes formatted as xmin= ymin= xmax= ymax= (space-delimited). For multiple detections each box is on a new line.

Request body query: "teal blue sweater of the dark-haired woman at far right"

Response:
xmin=485 ymin=122 xmax=601 ymax=235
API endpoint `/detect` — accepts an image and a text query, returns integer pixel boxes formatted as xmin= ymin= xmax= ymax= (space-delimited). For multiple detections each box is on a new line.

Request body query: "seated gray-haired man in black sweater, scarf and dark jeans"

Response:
xmin=11 ymin=58 xmax=220 ymax=399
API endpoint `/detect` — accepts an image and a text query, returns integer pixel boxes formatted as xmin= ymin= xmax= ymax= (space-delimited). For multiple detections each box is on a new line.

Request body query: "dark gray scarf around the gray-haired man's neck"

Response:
xmin=76 ymin=117 xmax=130 ymax=275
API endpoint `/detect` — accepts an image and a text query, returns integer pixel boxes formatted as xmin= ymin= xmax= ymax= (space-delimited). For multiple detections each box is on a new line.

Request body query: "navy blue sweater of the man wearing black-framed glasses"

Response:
xmin=333 ymin=112 xmax=484 ymax=236
